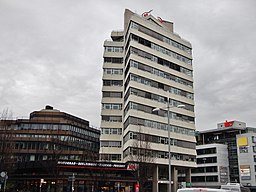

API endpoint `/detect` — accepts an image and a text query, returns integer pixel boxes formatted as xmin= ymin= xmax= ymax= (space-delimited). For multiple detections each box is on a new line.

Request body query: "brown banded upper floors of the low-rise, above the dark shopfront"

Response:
xmin=0 ymin=106 xmax=100 ymax=165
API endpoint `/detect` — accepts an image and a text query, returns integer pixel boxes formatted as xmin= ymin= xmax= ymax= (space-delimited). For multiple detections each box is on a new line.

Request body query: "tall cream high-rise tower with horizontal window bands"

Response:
xmin=100 ymin=9 xmax=196 ymax=191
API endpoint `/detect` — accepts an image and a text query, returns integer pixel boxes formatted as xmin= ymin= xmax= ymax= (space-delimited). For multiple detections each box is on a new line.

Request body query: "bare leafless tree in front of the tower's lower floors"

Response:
xmin=129 ymin=128 xmax=155 ymax=192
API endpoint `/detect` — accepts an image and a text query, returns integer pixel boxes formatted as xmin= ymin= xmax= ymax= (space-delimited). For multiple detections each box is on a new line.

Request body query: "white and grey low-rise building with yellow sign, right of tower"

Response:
xmin=192 ymin=121 xmax=256 ymax=191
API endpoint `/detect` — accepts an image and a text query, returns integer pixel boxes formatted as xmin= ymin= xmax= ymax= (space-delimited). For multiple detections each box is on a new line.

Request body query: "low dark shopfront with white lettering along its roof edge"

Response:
xmin=6 ymin=161 xmax=144 ymax=192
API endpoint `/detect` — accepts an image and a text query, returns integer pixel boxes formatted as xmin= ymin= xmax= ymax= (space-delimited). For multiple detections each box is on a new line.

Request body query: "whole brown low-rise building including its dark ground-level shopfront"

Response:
xmin=0 ymin=106 xmax=138 ymax=191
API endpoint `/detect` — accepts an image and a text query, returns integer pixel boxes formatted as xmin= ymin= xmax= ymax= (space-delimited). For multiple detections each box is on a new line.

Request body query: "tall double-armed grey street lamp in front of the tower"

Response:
xmin=153 ymin=103 xmax=185 ymax=192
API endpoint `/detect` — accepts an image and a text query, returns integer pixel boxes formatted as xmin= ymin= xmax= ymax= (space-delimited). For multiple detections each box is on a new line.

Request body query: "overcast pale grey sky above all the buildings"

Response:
xmin=0 ymin=0 xmax=256 ymax=130
